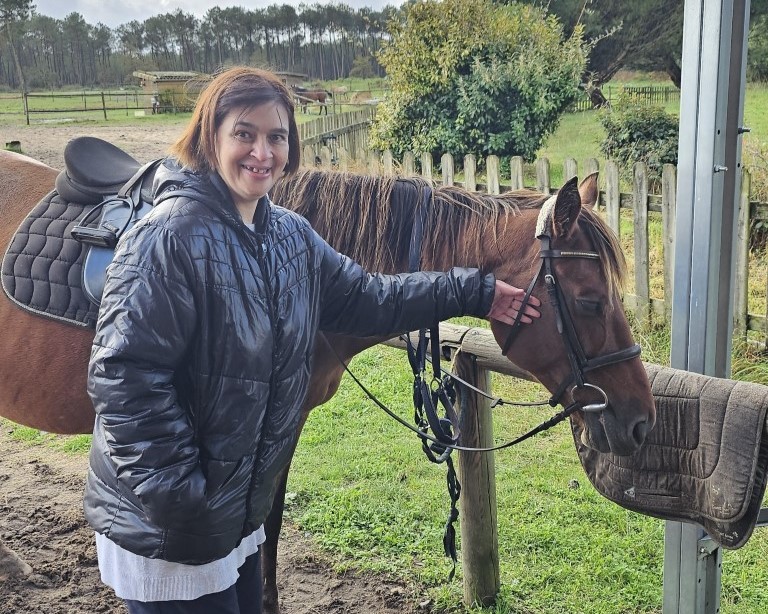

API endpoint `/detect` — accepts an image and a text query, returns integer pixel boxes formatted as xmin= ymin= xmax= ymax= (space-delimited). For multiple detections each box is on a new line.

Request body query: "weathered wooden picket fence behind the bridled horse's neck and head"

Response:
xmin=305 ymin=147 xmax=768 ymax=342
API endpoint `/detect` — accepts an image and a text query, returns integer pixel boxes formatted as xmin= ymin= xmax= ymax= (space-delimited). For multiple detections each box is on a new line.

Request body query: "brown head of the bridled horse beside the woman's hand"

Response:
xmin=491 ymin=175 xmax=656 ymax=455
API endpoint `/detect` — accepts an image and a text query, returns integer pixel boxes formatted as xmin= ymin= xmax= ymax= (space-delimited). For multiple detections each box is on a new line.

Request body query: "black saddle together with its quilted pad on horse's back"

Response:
xmin=0 ymin=137 xmax=160 ymax=327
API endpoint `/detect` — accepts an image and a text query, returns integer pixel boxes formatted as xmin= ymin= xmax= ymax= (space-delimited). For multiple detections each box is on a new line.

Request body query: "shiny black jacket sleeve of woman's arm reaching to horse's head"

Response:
xmin=317 ymin=236 xmax=496 ymax=336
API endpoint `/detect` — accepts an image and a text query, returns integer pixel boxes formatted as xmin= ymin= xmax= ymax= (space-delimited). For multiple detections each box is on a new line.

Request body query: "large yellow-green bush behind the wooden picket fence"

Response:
xmin=371 ymin=0 xmax=586 ymax=160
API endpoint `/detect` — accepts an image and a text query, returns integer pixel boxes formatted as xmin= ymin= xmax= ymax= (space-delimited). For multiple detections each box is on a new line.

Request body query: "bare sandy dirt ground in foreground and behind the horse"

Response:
xmin=0 ymin=122 xmax=416 ymax=614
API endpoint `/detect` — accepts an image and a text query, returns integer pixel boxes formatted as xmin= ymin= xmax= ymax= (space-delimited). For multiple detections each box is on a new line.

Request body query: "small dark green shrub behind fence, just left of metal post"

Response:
xmin=600 ymin=96 xmax=678 ymax=178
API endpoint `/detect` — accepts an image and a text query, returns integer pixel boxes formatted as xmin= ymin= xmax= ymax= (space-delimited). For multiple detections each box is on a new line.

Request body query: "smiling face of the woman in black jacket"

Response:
xmin=216 ymin=102 xmax=288 ymax=223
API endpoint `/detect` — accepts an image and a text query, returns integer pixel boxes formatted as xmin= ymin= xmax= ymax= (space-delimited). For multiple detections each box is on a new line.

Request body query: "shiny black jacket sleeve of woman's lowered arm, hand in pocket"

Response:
xmin=88 ymin=226 xmax=205 ymax=526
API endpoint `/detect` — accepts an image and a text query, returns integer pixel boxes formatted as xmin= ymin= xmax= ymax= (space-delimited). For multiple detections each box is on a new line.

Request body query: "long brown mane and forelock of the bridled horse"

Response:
xmin=272 ymin=170 xmax=626 ymax=294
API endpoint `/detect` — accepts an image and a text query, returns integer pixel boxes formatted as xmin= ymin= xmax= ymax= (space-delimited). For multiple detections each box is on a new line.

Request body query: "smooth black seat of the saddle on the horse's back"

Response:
xmin=56 ymin=136 xmax=141 ymax=205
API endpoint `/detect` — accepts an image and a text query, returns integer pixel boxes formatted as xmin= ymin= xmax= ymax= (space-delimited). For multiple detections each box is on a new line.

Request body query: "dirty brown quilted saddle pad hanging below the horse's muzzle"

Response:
xmin=571 ymin=364 xmax=768 ymax=549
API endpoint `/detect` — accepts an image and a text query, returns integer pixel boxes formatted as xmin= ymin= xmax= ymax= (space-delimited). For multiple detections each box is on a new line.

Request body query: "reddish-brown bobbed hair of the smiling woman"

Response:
xmin=170 ymin=66 xmax=301 ymax=175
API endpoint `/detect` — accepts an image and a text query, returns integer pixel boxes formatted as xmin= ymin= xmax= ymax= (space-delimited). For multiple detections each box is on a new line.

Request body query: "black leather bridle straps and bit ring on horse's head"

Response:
xmin=502 ymin=217 xmax=641 ymax=413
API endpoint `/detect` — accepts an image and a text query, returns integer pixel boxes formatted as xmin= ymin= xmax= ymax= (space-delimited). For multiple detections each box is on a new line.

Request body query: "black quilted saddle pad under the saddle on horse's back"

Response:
xmin=2 ymin=191 xmax=98 ymax=328
